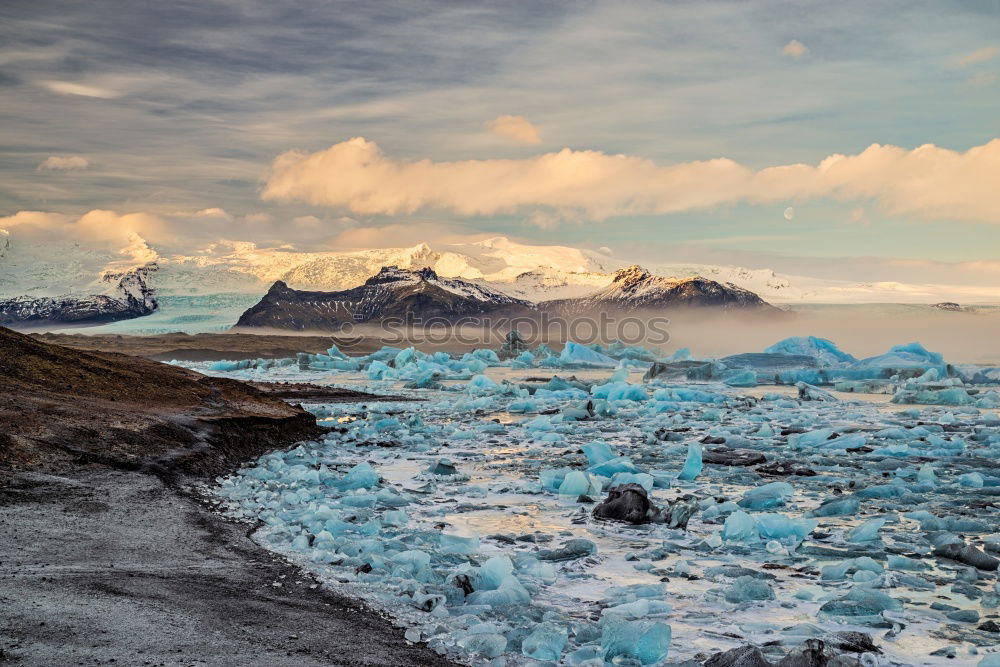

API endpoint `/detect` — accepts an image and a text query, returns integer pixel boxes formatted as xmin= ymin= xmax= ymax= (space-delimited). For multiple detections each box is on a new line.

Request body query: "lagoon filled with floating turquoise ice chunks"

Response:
xmin=194 ymin=346 xmax=1000 ymax=665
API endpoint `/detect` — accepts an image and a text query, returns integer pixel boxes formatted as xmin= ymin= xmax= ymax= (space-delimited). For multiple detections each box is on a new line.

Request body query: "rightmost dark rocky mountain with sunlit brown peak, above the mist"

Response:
xmin=542 ymin=265 xmax=782 ymax=312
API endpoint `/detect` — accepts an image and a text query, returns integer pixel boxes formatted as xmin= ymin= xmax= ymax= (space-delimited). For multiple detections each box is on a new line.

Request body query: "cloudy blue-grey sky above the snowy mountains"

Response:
xmin=0 ymin=0 xmax=1000 ymax=285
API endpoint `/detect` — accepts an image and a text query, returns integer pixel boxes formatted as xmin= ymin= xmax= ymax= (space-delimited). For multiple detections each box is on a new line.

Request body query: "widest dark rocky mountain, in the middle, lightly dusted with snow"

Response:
xmin=234 ymin=266 xmax=533 ymax=331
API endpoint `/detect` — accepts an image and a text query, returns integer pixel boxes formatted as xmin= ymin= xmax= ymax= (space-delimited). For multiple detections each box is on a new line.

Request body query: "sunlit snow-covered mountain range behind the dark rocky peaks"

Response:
xmin=0 ymin=230 xmax=1000 ymax=314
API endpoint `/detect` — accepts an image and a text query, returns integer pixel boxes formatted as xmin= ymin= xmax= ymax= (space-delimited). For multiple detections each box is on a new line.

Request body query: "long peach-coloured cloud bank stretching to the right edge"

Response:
xmin=262 ymin=137 xmax=1000 ymax=226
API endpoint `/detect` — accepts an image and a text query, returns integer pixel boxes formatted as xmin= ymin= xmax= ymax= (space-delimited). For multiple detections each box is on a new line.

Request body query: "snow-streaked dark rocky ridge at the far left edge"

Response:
xmin=0 ymin=264 xmax=158 ymax=326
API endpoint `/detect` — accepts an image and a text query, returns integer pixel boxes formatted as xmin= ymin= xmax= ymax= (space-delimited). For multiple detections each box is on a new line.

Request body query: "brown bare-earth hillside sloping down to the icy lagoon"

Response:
xmin=0 ymin=327 xmax=320 ymax=474
